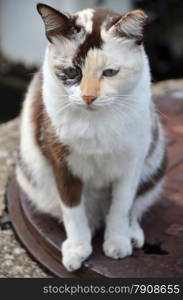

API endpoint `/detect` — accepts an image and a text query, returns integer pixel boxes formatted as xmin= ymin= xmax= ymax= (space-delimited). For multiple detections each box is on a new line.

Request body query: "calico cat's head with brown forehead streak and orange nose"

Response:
xmin=37 ymin=4 xmax=147 ymax=110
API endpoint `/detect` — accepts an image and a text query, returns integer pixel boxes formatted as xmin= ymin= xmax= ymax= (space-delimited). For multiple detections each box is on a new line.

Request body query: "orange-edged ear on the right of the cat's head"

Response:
xmin=111 ymin=9 xmax=148 ymax=44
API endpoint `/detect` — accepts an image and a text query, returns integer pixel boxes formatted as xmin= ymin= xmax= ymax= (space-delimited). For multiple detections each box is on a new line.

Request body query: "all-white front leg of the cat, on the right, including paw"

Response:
xmin=103 ymin=162 xmax=140 ymax=259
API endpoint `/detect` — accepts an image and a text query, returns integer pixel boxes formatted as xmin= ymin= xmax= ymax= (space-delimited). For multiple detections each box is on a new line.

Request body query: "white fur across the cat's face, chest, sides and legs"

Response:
xmin=17 ymin=7 xmax=164 ymax=271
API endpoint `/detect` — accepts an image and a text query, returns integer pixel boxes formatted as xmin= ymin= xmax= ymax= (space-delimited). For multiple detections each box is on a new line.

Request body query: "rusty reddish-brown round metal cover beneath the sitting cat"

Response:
xmin=7 ymin=95 xmax=183 ymax=278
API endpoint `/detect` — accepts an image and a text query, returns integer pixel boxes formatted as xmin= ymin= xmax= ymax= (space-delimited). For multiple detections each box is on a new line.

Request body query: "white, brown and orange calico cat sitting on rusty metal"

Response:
xmin=16 ymin=4 xmax=166 ymax=272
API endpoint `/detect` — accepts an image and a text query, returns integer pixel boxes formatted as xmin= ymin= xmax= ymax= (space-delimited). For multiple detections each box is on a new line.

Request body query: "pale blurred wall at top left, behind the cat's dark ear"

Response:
xmin=0 ymin=0 xmax=133 ymax=65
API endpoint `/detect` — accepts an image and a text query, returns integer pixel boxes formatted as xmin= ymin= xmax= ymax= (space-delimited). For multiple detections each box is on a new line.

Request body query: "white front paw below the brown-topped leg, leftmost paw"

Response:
xmin=62 ymin=240 xmax=92 ymax=272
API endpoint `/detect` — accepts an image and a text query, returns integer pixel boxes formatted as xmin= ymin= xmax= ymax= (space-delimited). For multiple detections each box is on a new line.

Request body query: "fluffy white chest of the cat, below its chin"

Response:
xmin=60 ymin=109 xmax=149 ymax=186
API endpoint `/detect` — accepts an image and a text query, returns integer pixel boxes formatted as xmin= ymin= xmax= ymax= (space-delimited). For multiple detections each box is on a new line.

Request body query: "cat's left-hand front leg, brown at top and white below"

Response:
xmin=54 ymin=161 xmax=92 ymax=272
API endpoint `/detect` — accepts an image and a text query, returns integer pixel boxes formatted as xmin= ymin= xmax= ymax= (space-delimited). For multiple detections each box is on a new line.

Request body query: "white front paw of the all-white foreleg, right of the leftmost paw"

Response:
xmin=103 ymin=238 xmax=133 ymax=259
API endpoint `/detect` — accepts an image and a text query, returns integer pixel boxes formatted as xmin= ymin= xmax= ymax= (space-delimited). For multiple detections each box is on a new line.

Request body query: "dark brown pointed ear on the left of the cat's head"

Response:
xmin=37 ymin=3 xmax=74 ymax=42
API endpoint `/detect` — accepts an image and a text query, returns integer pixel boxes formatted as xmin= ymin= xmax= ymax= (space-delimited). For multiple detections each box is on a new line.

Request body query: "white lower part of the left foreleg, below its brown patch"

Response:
xmin=62 ymin=201 xmax=92 ymax=271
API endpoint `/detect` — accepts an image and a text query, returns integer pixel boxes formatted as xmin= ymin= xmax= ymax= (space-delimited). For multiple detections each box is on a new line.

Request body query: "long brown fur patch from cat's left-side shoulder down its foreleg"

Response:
xmin=32 ymin=73 xmax=82 ymax=207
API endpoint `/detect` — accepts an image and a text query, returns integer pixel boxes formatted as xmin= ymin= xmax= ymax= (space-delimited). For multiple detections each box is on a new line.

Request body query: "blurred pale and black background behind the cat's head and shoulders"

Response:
xmin=0 ymin=0 xmax=183 ymax=123
